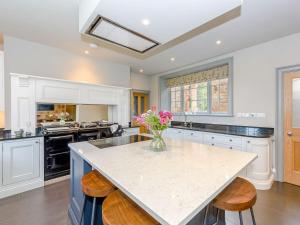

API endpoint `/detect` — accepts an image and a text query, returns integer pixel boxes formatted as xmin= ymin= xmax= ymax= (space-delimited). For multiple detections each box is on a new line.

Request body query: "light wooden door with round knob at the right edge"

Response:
xmin=284 ymin=70 xmax=300 ymax=186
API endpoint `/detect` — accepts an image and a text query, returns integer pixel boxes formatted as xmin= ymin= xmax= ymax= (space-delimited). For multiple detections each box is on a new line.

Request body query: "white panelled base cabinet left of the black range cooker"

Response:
xmin=0 ymin=138 xmax=44 ymax=198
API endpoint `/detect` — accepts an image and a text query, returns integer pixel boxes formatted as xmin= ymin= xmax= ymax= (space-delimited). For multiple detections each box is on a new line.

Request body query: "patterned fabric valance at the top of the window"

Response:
xmin=166 ymin=64 xmax=229 ymax=88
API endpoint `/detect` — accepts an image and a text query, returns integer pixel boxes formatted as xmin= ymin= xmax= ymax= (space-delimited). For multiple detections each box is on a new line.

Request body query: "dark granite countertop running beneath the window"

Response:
xmin=171 ymin=121 xmax=274 ymax=138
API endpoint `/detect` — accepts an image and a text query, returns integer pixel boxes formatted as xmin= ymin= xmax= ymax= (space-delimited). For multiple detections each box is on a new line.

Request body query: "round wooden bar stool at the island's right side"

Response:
xmin=213 ymin=177 xmax=257 ymax=225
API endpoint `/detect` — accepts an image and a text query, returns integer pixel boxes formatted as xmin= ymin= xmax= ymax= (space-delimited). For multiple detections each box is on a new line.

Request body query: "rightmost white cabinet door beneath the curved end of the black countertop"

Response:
xmin=245 ymin=139 xmax=271 ymax=180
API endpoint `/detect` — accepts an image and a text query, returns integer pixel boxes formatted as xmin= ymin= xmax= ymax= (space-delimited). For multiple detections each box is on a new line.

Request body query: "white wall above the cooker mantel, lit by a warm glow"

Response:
xmin=4 ymin=36 xmax=130 ymax=128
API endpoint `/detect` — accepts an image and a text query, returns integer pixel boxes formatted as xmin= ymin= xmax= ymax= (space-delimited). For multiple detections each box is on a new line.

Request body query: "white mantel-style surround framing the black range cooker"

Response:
xmin=11 ymin=74 xmax=130 ymax=132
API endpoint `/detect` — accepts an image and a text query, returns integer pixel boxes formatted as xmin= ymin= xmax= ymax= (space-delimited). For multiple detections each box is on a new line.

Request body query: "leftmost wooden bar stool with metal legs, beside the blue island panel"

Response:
xmin=79 ymin=170 xmax=115 ymax=225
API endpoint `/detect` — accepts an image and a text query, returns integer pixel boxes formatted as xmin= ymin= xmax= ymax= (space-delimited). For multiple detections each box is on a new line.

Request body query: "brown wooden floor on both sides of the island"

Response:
xmin=0 ymin=181 xmax=300 ymax=225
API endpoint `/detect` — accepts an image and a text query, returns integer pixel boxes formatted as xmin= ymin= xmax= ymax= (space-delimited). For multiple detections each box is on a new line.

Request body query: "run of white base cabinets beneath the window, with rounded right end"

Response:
xmin=163 ymin=128 xmax=274 ymax=190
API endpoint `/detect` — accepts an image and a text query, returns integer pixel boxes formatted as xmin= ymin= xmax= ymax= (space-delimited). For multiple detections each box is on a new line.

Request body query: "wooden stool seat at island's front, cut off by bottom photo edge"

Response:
xmin=102 ymin=190 xmax=159 ymax=225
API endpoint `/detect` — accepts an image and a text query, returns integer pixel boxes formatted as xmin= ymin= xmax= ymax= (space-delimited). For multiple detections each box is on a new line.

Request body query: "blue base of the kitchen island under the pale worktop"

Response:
xmin=68 ymin=151 xmax=226 ymax=225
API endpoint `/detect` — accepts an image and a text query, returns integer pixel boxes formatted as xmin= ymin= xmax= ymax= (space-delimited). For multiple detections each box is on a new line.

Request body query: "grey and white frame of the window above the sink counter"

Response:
xmin=160 ymin=57 xmax=233 ymax=117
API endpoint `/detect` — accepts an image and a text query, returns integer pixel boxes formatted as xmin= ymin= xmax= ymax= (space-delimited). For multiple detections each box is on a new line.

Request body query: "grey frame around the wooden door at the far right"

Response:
xmin=275 ymin=64 xmax=300 ymax=181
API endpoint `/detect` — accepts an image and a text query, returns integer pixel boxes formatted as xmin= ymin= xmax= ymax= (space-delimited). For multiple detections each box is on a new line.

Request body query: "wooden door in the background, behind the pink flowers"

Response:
xmin=131 ymin=92 xmax=149 ymax=130
